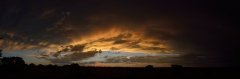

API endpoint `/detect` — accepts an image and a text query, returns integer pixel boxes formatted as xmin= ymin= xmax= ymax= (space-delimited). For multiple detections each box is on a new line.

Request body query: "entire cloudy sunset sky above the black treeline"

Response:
xmin=0 ymin=0 xmax=239 ymax=67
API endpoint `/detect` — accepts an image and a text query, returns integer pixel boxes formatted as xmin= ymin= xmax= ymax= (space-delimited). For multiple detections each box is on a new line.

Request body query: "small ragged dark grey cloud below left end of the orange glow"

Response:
xmin=37 ymin=45 xmax=102 ymax=64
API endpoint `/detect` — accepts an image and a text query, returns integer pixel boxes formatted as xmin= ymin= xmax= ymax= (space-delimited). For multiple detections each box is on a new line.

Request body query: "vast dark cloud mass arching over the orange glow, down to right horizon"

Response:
xmin=0 ymin=0 xmax=239 ymax=65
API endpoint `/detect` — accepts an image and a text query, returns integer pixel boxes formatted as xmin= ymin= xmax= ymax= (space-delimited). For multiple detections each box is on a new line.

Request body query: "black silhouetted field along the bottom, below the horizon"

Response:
xmin=0 ymin=65 xmax=240 ymax=79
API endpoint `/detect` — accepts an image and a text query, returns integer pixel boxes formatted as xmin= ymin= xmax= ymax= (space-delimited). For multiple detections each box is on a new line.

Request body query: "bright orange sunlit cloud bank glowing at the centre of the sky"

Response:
xmin=60 ymin=26 xmax=173 ymax=53
